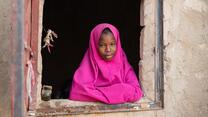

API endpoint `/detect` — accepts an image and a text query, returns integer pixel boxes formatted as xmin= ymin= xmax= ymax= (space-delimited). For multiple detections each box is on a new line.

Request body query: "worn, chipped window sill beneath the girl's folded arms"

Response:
xmin=28 ymin=98 xmax=162 ymax=116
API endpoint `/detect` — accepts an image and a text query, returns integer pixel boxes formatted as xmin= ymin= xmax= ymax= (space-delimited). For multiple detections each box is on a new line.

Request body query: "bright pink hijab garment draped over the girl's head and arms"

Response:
xmin=69 ymin=23 xmax=143 ymax=104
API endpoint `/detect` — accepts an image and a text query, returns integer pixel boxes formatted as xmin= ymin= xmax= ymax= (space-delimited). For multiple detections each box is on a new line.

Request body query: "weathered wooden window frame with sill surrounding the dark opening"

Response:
xmin=27 ymin=0 xmax=164 ymax=116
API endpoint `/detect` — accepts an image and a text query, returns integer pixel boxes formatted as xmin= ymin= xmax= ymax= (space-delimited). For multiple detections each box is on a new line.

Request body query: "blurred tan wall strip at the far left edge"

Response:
xmin=0 ymin=0 xmax=12 ymax=117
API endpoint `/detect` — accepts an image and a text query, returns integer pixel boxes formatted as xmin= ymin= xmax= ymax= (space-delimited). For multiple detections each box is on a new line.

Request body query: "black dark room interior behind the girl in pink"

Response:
xmin=41 ymin=0 xmax=141 ymax=99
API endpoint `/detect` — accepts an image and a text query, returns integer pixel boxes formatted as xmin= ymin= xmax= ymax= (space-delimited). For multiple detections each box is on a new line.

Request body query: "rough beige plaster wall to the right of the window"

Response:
xmin=162 ymin=0 xmax=208 ymax=117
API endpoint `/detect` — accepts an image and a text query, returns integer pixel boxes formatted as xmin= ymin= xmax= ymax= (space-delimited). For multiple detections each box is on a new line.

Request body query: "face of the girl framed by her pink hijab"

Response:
xmin=98 ymin=33 xmax=116 ymax=61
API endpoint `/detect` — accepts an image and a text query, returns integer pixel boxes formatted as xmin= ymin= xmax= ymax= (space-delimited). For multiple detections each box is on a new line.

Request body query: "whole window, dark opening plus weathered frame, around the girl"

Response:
xmin=26 ymin=0 xmax=163 ymax=115
